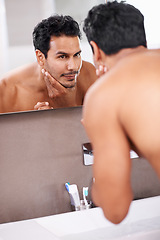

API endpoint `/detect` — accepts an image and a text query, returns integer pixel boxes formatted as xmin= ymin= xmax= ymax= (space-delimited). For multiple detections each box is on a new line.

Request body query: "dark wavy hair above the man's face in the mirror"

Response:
xmin=33 ymin=14 xmax=81 ymax=58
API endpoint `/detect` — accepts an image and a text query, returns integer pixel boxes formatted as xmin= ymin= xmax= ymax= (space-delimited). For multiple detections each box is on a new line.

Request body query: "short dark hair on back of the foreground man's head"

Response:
xmin=83 ymin=1 xmax=146 ymax=55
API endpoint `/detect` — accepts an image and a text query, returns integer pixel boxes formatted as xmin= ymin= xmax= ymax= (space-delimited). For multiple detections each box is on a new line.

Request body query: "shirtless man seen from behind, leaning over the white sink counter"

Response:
xmin=82 ymin=1 xmax=160 ymax=224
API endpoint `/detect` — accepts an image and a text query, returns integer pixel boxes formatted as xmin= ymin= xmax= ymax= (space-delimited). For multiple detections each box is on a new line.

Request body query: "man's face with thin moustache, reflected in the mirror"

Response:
xmin=44 ymin=35 xmax=82 ymax=88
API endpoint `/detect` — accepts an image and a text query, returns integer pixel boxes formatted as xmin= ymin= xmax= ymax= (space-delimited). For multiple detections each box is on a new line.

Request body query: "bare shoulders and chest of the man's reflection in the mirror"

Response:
xmin=0 ymin=61 xmax=96 ymax=113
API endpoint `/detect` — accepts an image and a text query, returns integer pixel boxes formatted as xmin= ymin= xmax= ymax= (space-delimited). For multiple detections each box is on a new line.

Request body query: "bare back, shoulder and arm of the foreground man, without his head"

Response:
xmin=83 ymin=50 xmax=160 ymax=222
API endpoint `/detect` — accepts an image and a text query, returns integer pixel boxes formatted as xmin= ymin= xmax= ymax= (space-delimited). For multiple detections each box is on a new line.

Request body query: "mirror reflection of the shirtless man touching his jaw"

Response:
xmin=0 ymin=15 xmax=97 ymax=113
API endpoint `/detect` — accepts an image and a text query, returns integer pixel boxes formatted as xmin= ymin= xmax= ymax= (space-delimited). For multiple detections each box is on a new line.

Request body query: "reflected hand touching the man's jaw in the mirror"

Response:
xmin=42 ymin=69 xmax=67 ymax=98
